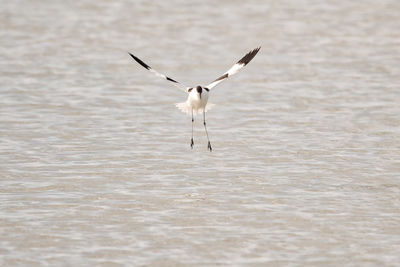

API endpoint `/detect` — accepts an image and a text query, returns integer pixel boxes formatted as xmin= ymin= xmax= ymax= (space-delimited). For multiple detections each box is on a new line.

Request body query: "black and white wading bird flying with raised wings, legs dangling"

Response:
xmin=129 ymin=47 xmax=261 ymax=152
